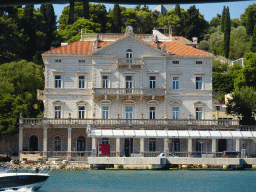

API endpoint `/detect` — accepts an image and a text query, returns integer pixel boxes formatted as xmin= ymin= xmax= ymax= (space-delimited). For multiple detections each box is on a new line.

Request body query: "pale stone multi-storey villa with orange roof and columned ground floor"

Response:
xmin=19 ymin=27 xmax=254 ymax=160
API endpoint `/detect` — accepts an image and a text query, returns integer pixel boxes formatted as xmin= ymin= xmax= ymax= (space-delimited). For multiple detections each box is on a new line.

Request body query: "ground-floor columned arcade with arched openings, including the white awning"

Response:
xmin=19 ymin=127 xmax=256 ymax=159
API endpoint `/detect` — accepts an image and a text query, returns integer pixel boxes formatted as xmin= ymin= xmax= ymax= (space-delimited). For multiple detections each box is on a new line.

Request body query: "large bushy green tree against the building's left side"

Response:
xmin=0 ymin=60 xmax=44 ymax=134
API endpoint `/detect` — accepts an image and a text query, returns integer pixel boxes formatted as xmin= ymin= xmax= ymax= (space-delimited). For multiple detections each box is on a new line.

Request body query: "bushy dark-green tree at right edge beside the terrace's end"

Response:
xmin=227 ymin=87 xmax=256 ymax=125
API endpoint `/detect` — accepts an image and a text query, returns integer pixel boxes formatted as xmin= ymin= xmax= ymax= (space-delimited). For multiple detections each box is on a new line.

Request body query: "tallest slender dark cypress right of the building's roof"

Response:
xmin=224 ymin=7 xmax=231 ymax=58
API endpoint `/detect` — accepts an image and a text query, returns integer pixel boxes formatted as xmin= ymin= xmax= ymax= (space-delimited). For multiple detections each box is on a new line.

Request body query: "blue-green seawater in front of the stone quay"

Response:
xmin=4 ymin=170 xmax=256 ymax=192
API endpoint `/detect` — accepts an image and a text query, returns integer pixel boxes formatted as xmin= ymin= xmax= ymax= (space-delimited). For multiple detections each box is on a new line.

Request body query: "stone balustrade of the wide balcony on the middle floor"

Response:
xmin=94 ymin=88 xmax=165 ymax=96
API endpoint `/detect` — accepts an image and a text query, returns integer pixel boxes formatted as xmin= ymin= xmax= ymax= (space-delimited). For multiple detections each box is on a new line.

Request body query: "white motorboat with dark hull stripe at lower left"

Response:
xmin=0 ymin=164 xmax=50 ymax=191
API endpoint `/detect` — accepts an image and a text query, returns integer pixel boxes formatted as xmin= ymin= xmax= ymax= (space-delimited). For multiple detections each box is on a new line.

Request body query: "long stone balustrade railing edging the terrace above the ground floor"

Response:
xmin=20 ymin=118 xmax=239 ymax=126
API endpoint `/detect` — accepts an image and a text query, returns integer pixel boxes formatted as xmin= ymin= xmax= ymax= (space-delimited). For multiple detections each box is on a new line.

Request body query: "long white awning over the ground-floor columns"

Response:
xmin=88 ymin=129 xmax=256 ymax=139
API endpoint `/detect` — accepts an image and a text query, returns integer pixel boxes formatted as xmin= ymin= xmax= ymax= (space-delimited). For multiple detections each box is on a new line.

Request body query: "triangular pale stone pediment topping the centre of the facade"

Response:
xmin=90 ymin=35 xmax=169 ymax=58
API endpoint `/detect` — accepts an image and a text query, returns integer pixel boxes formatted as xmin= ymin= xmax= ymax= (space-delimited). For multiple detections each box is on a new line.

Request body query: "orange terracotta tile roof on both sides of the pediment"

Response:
xmin=44 ymin=40 xmax=214 ymax=56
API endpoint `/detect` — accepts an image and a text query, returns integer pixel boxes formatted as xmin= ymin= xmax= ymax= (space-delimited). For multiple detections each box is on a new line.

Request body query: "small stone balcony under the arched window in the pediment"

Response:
xmin=116 ymin=58 xmax=144 ymax=69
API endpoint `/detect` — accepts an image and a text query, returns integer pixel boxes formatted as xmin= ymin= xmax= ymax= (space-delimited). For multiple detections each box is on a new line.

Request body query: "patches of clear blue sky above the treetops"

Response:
xmin=35 ymin=1 xmax=256 ymax=21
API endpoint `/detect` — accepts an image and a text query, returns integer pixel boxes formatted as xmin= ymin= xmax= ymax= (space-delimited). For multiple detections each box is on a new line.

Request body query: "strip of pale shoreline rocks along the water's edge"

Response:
xmin=4 ymin=160 xmax=256 ymax=170
